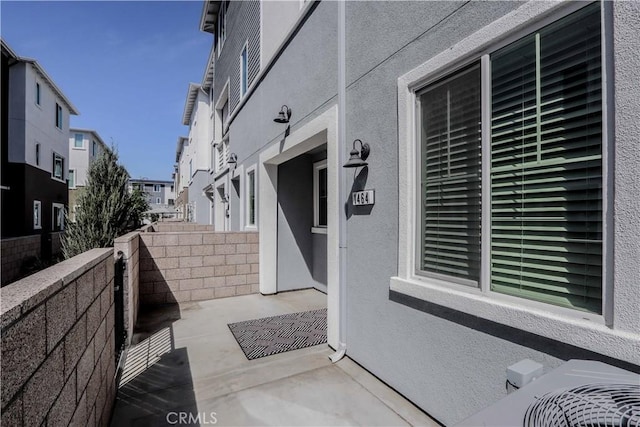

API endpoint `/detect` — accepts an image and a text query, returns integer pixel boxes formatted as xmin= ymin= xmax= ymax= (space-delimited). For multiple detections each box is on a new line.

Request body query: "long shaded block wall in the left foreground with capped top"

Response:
xmin=0 ymin=248 xmax=116 ymax=426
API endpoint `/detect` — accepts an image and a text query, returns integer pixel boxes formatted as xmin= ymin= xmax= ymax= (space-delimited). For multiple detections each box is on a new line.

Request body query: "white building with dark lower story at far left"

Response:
xmin=1 ymin=40 xmax=78 ymax=276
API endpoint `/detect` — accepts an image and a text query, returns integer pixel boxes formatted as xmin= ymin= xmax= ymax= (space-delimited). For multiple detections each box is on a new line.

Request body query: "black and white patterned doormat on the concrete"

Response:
xmin=227 ymin=308 xmax=327 ymax=360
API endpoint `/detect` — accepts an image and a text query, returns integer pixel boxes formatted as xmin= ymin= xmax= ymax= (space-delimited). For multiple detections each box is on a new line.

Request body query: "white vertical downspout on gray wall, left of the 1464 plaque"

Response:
xmin=329 ymin=1 xmax=348 ymax=363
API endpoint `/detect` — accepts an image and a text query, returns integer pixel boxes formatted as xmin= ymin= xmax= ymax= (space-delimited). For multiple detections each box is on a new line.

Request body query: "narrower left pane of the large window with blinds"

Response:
xmin=420 ymin=64 xmax=482 ymax=283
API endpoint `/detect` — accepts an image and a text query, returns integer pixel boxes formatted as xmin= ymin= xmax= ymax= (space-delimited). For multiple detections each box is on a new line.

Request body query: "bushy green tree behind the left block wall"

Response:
xmin=62 ymin=149 xmax=149 ymax=258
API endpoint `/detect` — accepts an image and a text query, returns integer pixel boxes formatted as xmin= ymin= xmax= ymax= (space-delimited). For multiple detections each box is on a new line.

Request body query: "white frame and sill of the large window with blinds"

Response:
xmin=390 ymin=2 xmax=614 ymax=326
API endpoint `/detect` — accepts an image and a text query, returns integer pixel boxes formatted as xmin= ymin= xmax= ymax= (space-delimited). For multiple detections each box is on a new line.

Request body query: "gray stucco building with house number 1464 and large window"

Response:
xmin=190 ymin=1 xmax=640 ymax=425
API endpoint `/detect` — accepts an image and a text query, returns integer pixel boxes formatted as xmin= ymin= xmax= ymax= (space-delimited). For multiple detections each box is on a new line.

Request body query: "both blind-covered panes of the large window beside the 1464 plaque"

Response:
xmin=415 ymin=3 xmax=605 ymax=314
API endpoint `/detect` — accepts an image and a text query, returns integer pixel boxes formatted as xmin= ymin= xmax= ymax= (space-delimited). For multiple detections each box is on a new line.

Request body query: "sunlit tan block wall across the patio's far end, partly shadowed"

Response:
xmin=140 ymin=232 xmax=259 ymax=305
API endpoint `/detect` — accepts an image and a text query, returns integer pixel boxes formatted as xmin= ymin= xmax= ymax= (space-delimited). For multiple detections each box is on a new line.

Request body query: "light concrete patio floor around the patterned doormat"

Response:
xmin=112 ymin=290 xmax=437 ymax=426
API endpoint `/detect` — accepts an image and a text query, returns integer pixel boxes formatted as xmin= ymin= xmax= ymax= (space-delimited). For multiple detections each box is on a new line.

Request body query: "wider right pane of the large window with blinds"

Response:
xmin=491 ymin=3 xmax=602 ymax=313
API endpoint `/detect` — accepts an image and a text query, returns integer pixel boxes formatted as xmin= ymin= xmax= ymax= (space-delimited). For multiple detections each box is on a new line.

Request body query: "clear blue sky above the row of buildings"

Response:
xmin=0 ymin=0 xmax=213 ymax=180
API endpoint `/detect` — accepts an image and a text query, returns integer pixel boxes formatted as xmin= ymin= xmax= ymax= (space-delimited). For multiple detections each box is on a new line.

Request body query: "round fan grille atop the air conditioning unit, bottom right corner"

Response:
xmin=523 ymin=384 xmax=640 ymax=427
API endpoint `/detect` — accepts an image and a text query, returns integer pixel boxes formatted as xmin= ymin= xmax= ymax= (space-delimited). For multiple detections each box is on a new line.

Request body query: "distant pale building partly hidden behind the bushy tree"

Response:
xmin=68 ymin=128 xmax=109 ymax=221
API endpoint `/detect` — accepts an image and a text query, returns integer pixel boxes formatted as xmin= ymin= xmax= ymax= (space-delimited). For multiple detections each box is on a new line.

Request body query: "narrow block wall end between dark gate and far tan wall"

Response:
xmin=113 ymin=231 xmax=140 ymax=344
